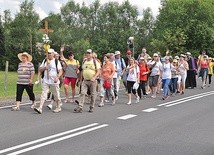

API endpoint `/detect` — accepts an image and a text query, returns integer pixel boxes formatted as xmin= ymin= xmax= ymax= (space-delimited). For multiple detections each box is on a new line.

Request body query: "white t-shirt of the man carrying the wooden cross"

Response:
xmin=40 ymin=59 xmax=62 ymax=84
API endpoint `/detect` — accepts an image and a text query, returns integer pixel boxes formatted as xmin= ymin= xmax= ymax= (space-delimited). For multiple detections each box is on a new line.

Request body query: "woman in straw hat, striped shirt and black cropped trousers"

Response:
xmin=12 ymin=52 xmax=35 ymax=111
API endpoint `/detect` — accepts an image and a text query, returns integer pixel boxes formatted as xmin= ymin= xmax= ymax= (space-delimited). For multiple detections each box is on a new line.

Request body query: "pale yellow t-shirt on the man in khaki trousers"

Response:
xmin=82 ymin=59 xmax=100 ymax=80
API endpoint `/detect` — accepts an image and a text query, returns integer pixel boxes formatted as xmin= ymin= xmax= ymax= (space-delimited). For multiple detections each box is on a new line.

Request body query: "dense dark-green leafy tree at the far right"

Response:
xmin=153 ymin=0 xmax=214 ymax=54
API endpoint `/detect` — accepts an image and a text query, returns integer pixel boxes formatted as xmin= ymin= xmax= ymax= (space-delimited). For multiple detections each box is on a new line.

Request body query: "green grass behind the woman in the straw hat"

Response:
xmin=0 ymin=71 xmax=41 ymax=99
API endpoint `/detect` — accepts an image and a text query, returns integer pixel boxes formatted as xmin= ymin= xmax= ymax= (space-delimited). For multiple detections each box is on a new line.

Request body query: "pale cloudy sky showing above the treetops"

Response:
xmin=0 ymin=0 xmax=160 ymax=19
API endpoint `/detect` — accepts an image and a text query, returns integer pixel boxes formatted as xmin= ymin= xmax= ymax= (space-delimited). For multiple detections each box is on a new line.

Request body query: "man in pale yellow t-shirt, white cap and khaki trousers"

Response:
xmin=74 ymin=49 xmax=101 ymax=113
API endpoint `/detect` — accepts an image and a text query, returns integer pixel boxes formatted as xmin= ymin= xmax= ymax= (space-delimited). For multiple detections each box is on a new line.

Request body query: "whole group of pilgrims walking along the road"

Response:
xmin=12 ymin=47 xmax=214 ymax=114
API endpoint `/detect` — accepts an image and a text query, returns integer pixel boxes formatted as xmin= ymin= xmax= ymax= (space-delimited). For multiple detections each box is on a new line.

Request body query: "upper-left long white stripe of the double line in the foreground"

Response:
xmin=0 ymin=123 xmax=98 ymax=154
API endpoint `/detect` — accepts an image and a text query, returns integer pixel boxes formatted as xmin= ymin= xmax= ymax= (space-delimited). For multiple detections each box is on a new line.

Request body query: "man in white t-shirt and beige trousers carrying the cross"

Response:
xmin=34 ymin=49 xmax=63 ymax=114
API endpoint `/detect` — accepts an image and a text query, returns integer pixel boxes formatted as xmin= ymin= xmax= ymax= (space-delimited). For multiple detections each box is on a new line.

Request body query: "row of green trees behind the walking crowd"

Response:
xmin=0 ymin=0 xmax=214 ymax=71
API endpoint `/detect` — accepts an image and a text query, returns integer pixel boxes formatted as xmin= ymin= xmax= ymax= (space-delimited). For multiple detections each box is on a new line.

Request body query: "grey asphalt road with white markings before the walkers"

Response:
xmin=0 ymin=85 xmax=214 ymax=155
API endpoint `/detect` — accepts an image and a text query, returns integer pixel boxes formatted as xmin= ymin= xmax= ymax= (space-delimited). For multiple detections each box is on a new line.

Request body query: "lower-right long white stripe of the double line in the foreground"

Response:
xmin=8 ymin=124 xmax=108 ymax=155
